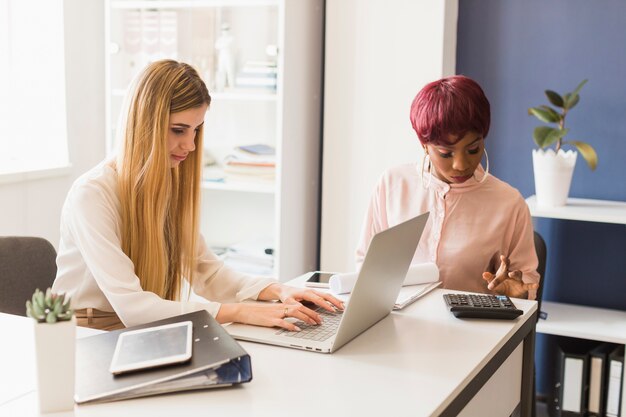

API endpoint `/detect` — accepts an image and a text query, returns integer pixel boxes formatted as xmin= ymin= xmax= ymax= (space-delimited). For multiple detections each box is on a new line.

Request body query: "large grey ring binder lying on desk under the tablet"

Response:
xmin=74 ymin=310 xmax=252 ymax=404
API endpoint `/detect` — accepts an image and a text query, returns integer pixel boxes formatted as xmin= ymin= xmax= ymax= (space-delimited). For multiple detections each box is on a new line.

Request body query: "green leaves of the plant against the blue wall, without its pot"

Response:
xmin=528 ymin=80 xmax=598 ymax=171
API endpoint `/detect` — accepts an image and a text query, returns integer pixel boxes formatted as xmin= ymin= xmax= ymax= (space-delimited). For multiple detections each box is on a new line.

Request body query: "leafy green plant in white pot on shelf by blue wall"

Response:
xmin=528 ymin=80 xmax=598 ymax=206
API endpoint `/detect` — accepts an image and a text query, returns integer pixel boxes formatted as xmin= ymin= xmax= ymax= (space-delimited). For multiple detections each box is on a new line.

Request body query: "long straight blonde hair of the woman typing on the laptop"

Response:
xmin=116 ymin=60 xmax=211 ymax=300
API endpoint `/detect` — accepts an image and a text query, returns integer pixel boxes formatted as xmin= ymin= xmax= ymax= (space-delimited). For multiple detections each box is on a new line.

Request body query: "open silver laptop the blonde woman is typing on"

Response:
xmin=226 ymin=212 xmax=429 ymax=353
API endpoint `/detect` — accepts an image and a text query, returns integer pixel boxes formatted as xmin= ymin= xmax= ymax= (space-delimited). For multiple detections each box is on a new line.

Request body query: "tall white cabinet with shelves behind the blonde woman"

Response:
xmin=105 ymin=0 xmax=324 ymax=280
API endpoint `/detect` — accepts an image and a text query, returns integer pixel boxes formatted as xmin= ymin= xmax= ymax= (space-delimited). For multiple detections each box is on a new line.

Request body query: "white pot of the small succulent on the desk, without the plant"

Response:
xmin=35 ymin=317 xmax=76 ymax=413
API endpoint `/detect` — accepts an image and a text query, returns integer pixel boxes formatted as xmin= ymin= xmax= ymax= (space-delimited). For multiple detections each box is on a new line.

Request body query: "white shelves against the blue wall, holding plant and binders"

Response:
xmin=526 ymin=195 xmax=626 ymax=415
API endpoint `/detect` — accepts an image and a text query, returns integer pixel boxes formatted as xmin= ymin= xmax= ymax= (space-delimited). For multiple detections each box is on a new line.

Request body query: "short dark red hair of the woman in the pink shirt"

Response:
xmin=410 ymin=75 xmax=491 ymax=145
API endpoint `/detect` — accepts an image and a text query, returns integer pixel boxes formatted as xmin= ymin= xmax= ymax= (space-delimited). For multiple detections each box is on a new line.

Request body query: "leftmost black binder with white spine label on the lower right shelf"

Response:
xmin=552 ymin=338 xmax=598 ymax=417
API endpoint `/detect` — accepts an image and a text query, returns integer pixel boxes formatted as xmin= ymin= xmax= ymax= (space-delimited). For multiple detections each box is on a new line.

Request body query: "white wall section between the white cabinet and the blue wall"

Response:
xmin=320 ymin=0 xmax=458 ymax=272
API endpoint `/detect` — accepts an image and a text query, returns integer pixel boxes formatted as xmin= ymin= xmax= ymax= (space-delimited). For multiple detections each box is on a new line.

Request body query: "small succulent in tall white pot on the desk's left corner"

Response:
xmin=26 ymin=288 xmax=76 ymax=413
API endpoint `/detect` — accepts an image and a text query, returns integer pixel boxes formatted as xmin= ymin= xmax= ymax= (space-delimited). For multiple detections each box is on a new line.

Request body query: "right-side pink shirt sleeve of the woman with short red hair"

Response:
xmin=509 ymin=197 xmax=540 ymax=300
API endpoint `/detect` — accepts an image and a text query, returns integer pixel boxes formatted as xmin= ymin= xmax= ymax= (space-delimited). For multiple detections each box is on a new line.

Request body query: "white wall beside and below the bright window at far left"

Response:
xmin=0 ymin=0 xmax=104 ymax=247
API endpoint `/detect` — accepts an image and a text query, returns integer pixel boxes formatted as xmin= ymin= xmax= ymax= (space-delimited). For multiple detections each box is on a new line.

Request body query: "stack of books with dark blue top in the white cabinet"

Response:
xmin=224 ymin=144 xmax=276 ymax=182
